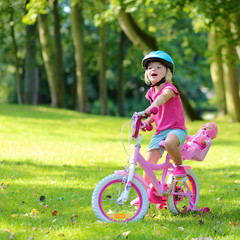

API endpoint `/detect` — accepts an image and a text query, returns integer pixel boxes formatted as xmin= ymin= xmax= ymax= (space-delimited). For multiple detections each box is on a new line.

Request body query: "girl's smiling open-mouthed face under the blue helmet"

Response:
xmin=147 ymin=62 xmax=167 ymax=84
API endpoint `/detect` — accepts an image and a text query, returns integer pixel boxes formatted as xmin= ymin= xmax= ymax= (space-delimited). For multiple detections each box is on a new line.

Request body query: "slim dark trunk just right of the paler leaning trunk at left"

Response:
xmin=49 ymin=0 xmax=66 ymax=107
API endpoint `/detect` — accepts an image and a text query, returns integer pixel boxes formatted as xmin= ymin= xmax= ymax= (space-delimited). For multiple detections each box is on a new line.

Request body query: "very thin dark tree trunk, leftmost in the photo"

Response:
xmin=10 ymin=8 xmax=23 ymax=104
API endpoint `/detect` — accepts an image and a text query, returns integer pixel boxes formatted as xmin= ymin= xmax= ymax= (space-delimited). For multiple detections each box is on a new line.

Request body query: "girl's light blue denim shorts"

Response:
xmin=147 ymin=129 xmax=187 ymax=155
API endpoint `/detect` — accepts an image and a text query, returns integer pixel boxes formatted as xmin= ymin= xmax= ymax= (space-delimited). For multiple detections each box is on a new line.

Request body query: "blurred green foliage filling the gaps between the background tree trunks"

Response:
xmin=0 ymin=0 xmax=239 ymax=114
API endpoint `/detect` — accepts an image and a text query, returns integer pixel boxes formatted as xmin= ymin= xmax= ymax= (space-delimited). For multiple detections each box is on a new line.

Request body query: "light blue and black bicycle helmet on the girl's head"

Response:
xmin=142 ymin=51 xmax=174 ymax=73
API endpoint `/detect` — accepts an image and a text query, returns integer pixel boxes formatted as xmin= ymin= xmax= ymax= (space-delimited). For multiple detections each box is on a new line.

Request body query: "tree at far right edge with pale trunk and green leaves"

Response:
xmin=185 ymin=0 xmax=240 ymax=122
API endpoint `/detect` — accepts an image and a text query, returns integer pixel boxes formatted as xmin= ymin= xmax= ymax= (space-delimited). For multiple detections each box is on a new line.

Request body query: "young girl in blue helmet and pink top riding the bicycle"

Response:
xmin=142 ymin=51 xmax=187 ymax=183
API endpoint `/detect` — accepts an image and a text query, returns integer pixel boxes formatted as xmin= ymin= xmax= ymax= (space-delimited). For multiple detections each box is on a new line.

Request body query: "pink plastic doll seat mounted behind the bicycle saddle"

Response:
xmin=181 ymin=143 xmax=212 ymax=161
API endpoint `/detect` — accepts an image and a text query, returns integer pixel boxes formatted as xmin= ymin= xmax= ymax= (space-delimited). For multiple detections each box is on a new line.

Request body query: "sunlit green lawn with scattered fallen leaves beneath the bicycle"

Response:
xmin=0 ymin=105 xmax=240 ymax=240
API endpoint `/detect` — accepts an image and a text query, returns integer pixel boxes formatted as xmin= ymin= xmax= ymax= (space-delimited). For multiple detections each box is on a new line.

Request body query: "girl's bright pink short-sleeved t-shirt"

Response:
xmin=145 ymin=82 xmax=186 ymax=135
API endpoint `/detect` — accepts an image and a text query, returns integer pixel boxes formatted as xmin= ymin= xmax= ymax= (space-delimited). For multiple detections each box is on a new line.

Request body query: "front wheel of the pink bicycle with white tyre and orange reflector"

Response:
xmin=92 ymin=174 xmax=149 ymax=222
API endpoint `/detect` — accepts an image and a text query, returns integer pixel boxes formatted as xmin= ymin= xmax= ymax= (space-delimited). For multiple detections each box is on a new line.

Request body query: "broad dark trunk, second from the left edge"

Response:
xmin=24 ymin=22 xmax=39 ymax=104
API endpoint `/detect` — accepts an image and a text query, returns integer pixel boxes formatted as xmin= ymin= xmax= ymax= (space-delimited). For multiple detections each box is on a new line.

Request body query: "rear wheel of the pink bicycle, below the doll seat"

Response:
xmin=167 ymin=170 xmax=200 ymax=214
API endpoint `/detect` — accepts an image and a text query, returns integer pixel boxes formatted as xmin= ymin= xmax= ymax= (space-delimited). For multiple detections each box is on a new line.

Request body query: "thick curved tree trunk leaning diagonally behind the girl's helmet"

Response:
xmin=118 ymin=9 xmax=201 ymax=120
